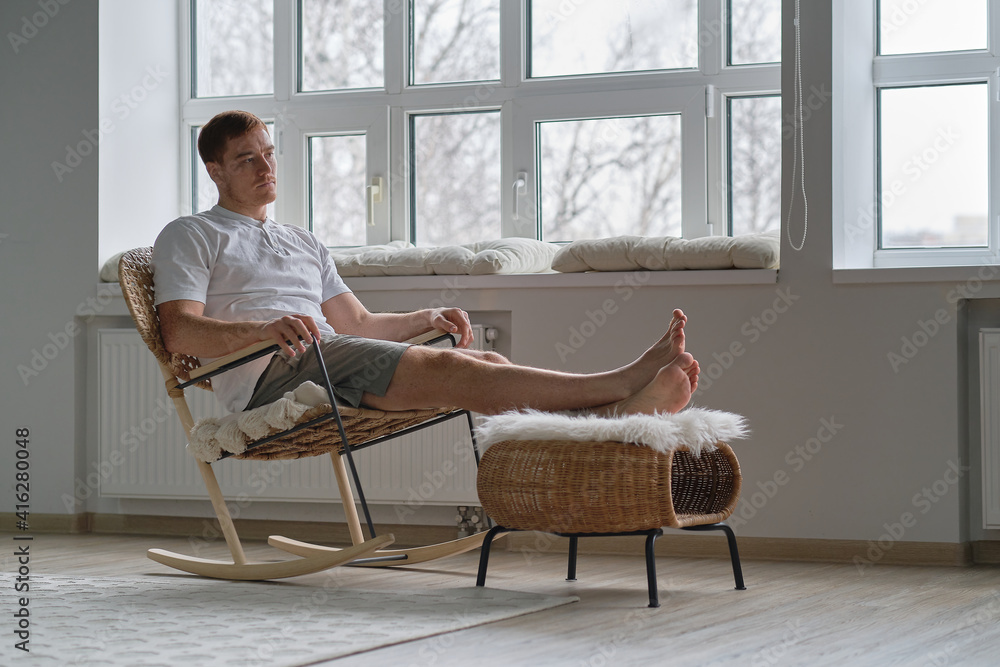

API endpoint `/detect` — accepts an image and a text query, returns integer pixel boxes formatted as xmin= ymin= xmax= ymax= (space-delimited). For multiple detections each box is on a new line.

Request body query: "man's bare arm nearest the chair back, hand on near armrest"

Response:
xmin=157 ymin=299 xmax=320 ymax=357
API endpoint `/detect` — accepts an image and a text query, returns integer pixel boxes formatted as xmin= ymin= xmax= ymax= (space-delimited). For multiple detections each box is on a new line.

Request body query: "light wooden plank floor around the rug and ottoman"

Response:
xmin=0 ymin=535 xmax=1000 ymax=667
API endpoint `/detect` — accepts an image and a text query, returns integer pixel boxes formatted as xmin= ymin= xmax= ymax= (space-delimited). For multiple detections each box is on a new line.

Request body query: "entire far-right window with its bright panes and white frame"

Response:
xmin=836 ymin=0 xmax=1000 ymax=268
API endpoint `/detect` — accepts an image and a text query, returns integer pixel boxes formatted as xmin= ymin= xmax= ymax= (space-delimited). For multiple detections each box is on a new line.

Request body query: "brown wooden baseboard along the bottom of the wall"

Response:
xmin=0 ymin=512 xmax=1000 ymax=567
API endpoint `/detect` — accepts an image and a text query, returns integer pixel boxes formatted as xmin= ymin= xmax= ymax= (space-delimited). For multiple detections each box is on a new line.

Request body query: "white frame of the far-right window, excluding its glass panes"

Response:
xmin=832 ymin=0 xmax=1000 ymax=269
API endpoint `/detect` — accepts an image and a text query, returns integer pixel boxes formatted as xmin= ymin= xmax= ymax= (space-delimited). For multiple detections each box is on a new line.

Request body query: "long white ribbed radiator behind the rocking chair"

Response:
xmin=97 ymin=326 xmax=493 ymax=506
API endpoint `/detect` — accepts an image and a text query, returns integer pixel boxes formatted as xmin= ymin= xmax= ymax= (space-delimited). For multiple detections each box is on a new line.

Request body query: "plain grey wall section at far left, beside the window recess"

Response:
xmin=0 ymin=0 xmax=98 ymax=513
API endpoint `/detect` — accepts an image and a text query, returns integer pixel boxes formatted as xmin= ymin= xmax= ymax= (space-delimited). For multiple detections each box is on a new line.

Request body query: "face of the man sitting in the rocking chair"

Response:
xmin=206 ymin=128 xmax=277 ymax=217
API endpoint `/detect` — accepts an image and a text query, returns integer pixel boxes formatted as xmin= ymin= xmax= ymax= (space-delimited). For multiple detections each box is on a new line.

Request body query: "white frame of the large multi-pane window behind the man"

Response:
xmin=178 ymin=0 xmax=781 ymax=244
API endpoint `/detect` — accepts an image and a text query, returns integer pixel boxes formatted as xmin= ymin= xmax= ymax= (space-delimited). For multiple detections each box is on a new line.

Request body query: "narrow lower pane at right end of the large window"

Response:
xmin=729 ymin=96 xmax=781 ymax=236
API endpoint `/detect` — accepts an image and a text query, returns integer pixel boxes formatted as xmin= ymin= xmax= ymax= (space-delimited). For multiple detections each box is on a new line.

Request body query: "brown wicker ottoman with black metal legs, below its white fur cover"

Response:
xmin=476 ymin=440 xmax=744 ymax=607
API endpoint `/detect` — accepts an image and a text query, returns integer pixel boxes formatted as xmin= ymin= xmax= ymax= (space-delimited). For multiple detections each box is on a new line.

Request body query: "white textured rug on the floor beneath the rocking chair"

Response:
xmin=0 ymin=576 xmax=577 ymax=667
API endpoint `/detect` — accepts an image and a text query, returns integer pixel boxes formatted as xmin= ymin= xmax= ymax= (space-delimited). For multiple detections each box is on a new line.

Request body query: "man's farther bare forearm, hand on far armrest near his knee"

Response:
xmin=322 ymin=292 xmax=472 ymax=347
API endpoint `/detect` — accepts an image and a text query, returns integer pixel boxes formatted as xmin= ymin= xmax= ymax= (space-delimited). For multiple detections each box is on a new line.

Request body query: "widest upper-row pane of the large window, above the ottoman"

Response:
xmin=530 ymin=0 xmax=698 ymax=77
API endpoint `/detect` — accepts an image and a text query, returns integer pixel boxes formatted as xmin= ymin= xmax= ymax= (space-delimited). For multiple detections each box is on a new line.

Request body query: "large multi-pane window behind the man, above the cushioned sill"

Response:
xmin=182 ymin=0 xmax=782 ymax=246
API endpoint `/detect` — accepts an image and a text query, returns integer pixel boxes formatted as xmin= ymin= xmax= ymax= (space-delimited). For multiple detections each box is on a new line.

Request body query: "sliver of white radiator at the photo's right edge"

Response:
xmin=979 ymin=329 xmax=1000 ymax=528
